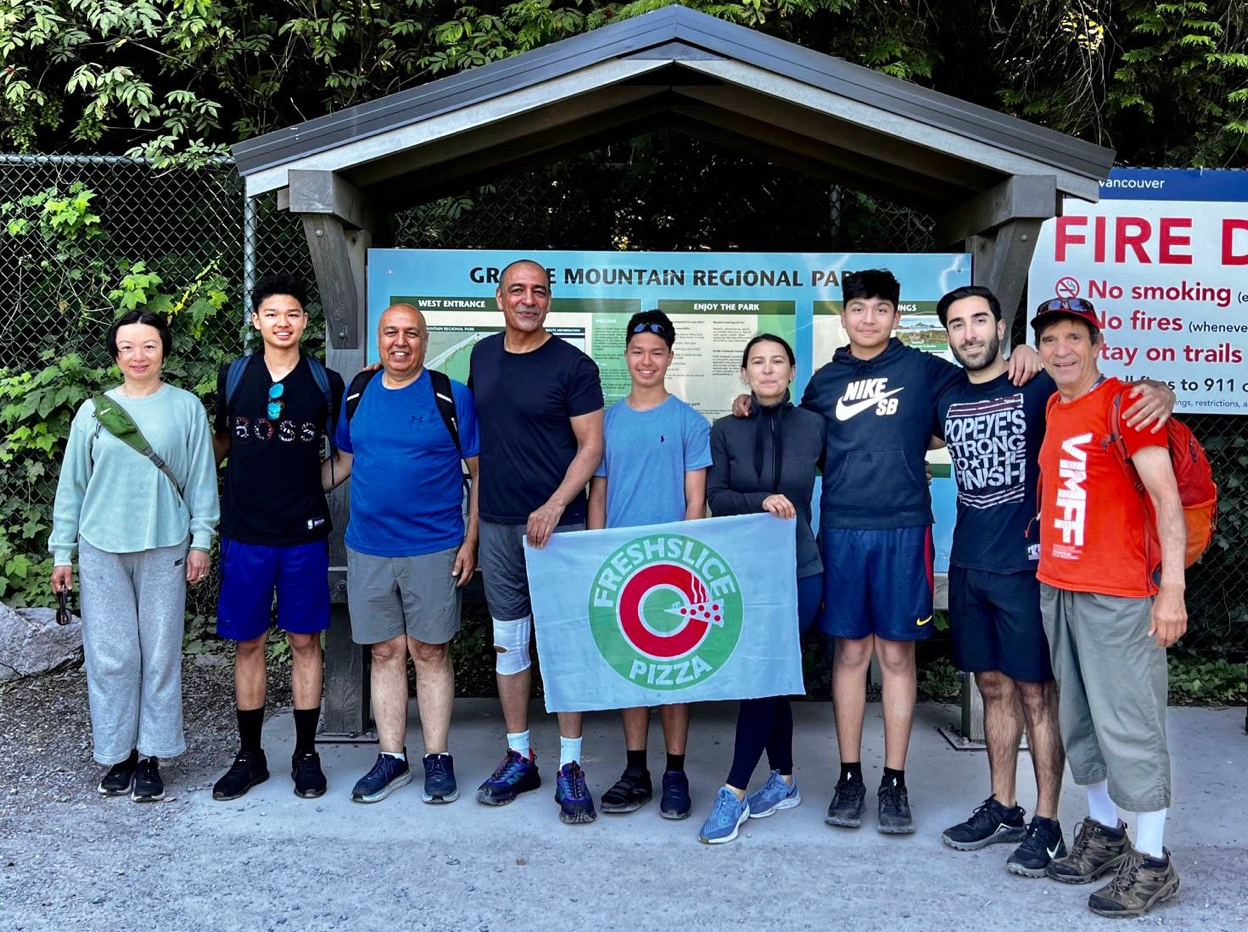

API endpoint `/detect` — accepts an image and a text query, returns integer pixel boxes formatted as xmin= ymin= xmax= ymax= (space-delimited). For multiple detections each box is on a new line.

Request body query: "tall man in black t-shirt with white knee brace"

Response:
xmin=468 ymin=260 xmax=603 ymax=825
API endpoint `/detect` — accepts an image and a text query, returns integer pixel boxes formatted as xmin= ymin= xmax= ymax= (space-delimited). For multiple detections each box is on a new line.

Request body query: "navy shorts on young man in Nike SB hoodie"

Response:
xmin=819 ymin=527 xmax=934 ymax=641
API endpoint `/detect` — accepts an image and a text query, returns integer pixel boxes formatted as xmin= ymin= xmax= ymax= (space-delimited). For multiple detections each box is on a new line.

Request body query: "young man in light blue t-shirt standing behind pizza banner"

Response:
xmin=588 ymin=311 xmax=710 ymax=818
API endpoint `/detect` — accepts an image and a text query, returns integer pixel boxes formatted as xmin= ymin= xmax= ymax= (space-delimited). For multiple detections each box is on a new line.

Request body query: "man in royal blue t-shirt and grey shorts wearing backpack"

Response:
xmin=327 ymin=304 xmax=478 ymax=803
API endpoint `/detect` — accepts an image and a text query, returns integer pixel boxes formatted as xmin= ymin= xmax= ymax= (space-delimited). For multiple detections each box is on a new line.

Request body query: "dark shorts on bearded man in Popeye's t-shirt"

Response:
xmin=948 ymin=566 xmax=1053 ymax=682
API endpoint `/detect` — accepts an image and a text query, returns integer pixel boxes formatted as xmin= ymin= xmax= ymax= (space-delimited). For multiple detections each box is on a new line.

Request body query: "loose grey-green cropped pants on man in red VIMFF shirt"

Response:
xmin=1040 ymin=583 xmax=1171 ymax=812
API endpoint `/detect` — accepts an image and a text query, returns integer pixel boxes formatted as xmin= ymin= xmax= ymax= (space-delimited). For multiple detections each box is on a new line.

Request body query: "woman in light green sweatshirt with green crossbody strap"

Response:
xmin=49 ymin=311 xmax=220 ymax=802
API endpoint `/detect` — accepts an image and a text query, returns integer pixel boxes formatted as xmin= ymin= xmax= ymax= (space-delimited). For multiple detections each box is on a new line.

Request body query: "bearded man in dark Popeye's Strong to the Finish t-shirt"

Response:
xmin=936 ymin=286 xmax=1173 ymax=877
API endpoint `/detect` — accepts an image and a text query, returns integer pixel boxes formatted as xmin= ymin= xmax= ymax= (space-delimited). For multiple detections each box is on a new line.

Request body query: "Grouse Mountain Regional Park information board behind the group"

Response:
xmin=368 ymin=250 xmax=971 ymax=571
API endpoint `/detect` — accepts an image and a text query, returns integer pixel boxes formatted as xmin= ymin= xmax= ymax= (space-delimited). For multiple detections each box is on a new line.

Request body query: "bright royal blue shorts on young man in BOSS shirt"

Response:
xmin=217 ymin=538 xmax=329 ymax=641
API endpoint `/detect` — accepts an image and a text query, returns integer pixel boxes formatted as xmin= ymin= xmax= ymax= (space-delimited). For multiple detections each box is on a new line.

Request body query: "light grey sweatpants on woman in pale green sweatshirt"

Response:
xmin=79 ymin=539 xmax=190 ymax=766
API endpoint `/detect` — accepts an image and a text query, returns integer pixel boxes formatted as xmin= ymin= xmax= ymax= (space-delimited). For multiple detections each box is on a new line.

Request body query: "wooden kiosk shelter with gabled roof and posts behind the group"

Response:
xmin=233 ymin=6 xmax=1113 ymax=735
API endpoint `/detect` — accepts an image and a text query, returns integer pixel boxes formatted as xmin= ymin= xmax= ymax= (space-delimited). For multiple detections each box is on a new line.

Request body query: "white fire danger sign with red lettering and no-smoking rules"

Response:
xmin=1027 ymin=168 xmax=1248 ymax=414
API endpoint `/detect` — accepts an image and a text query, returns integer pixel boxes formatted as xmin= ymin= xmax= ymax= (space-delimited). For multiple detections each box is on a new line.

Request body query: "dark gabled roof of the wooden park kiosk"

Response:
xmin=233 ymin=6 xmax=1113 ymax=212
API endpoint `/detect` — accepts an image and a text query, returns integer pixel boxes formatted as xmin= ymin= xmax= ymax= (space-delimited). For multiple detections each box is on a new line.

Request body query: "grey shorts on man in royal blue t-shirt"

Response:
xmin=347 ymin=546 xmax=459 ymax=644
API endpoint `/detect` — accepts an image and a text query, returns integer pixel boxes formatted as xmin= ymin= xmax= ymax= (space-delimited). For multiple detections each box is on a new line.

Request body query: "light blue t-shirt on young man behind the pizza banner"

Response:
xmin=594 ymin=396 xmax=711 ymax=528
